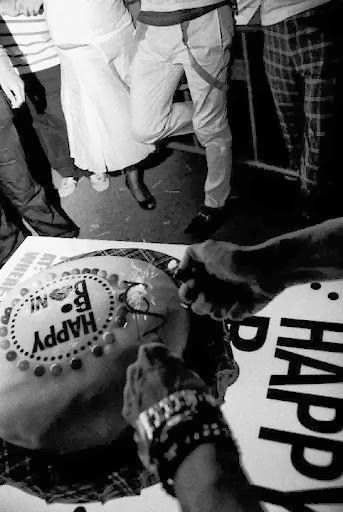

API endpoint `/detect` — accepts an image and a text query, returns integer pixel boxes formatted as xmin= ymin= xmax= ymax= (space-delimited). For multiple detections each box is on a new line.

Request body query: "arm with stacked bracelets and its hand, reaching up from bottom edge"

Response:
xmin=123 ymin=343 xmax=262 ymax=512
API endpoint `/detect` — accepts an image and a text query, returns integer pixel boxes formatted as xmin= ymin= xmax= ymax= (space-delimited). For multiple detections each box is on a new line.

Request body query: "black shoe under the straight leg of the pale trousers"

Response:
xmin=184 ymin=206 xmax=225 ymax=240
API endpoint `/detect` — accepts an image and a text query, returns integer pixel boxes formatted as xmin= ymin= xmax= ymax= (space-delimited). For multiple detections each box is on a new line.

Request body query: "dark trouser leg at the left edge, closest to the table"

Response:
xmin=0 ymin=93 xmax=79 ymax=237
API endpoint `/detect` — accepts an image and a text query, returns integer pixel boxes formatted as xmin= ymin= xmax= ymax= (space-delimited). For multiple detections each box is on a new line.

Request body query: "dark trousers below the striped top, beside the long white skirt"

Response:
xmin=16 ymin=66 xmax=89 ymax=178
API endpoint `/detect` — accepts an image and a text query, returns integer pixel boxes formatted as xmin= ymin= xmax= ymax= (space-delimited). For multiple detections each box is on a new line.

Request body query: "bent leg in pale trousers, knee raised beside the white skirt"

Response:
xmin=130 ymin=24 xmax=193 ymax=143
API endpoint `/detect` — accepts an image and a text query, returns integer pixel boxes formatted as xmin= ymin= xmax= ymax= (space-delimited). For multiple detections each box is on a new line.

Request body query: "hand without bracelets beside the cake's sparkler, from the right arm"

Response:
xmin=176 ymin=240 xmax=283 ymax=320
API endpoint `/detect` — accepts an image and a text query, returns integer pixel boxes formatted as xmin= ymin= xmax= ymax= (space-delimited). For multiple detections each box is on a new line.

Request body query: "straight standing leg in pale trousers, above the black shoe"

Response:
xmin=183 ymin=6 xmax=234 ymax=212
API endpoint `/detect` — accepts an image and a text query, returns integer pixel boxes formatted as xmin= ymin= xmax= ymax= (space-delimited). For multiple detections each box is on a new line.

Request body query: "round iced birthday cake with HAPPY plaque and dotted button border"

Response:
xmin=0 ymin=256 xmax=189 ymax=453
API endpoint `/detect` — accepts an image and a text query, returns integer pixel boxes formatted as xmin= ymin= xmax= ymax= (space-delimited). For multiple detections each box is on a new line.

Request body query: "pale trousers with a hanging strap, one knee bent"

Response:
xmin=130 ymin=6 xmax=234 ymax=208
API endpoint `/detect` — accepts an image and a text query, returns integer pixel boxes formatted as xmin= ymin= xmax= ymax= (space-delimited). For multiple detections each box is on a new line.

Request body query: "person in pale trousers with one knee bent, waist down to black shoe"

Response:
xmin=127 ymin=0 xmax=235 ymax=239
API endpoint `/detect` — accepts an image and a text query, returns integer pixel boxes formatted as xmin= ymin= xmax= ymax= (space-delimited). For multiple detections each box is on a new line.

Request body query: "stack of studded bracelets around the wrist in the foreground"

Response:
xmin=134 ymin=389 xmax=237 ymax=495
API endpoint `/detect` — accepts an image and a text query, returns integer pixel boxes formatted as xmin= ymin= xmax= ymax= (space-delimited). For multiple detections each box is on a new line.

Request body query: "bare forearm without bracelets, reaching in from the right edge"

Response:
xmin=237 ymin=218 xmax=343 ymax=286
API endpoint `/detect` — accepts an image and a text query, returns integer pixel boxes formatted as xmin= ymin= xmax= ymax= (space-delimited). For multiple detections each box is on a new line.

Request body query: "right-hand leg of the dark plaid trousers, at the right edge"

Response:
xmin=294 ymin=4 xmax=340 ymax=192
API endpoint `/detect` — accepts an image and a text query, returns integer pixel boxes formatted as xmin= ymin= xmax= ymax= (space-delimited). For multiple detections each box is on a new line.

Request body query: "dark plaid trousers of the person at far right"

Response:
xmin=264 ymin=0 xmax=342 ymax=190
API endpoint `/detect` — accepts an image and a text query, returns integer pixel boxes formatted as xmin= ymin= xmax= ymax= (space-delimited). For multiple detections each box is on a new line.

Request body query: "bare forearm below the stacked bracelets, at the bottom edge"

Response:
xmin=174 ymin=444 xmax=262 ymax=512
